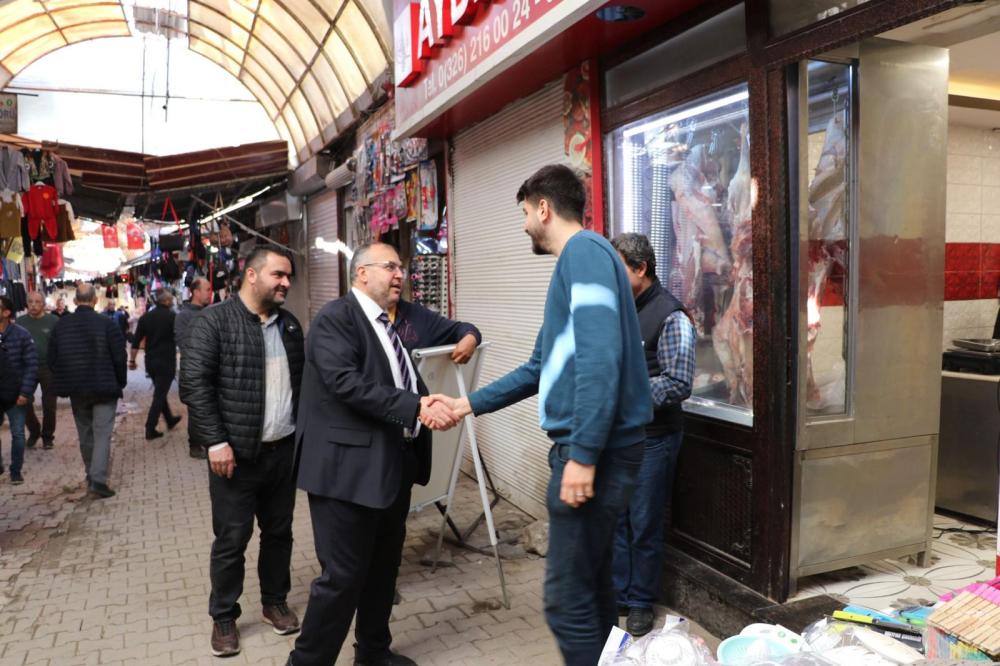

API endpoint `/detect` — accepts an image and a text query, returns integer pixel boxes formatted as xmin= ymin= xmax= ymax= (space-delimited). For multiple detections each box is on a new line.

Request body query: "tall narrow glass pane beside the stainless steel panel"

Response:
xmin=799 ymin=60 xmax=854 ymax=417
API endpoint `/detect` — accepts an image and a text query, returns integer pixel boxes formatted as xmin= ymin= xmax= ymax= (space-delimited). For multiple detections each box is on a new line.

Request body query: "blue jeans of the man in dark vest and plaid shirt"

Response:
xmin=614 ymin=432 xmax=683 ymax=609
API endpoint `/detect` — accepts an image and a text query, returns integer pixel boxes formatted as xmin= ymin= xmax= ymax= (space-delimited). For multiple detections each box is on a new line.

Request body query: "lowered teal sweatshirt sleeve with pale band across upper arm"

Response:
xmin=565 ymin=242 xmax=622 ymax=465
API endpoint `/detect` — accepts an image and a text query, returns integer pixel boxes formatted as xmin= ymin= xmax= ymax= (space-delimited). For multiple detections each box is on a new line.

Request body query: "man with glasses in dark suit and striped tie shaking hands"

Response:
xmin=288 ymin=244 xmax=455 ymax=666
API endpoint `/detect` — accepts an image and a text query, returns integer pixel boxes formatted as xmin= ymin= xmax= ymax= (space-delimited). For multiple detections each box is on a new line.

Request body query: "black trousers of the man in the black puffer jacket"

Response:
xmin=208 ymin=437 xmax=295 ymax=621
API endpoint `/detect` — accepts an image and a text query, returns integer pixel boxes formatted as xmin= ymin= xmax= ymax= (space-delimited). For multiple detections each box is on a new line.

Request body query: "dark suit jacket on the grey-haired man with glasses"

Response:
xmin=295 ymin=293 xmax=431 ymax=509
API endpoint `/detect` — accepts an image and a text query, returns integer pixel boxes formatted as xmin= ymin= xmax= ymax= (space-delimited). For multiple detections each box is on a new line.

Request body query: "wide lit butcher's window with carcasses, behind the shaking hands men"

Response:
xmin=609 ymin=84 xmax=754 ymax=425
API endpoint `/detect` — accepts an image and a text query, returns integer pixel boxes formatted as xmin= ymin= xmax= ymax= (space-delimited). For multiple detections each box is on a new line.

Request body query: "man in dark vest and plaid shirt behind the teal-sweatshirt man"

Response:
xmin=611 ymin=233 xmax=695 ymax=636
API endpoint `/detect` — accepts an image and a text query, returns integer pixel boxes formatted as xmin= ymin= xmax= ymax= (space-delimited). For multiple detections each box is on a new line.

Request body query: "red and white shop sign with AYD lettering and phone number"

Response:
xmin=393 ymin=0 xmax=603 ymax=136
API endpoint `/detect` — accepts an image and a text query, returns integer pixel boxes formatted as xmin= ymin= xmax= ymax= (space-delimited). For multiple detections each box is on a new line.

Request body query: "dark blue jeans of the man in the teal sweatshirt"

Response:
xmin=545 ymin=443 xmax=643 ymax=666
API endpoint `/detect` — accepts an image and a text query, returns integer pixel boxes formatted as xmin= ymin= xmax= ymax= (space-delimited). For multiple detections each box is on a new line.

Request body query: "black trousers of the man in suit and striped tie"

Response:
xmin=291 ymin=454 xmax=416 ymax=666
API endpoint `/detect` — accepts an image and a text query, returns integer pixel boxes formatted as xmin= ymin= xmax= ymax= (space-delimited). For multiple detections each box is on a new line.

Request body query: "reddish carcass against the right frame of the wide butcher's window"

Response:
xmin=712 ymin=124 xmax=753 ymax=406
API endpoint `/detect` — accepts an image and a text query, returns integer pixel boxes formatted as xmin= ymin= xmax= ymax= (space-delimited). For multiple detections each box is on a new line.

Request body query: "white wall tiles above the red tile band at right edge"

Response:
xmin=945 ymin=125 xmax=1000 ymax=243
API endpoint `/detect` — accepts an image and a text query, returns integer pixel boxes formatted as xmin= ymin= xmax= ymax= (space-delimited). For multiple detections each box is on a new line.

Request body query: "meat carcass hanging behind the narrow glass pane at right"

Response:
xmin=806 ymin=113 xmax=847 ymax=408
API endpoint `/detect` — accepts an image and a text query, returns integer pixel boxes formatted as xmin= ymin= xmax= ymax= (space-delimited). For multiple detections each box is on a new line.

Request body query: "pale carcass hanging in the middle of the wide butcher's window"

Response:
xmin=670 ymin=146 xmax=731 ymax=335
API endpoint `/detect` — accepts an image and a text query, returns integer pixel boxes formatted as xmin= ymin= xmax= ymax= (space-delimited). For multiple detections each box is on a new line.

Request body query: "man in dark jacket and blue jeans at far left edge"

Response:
xmin=0 ymin=296 xmax=38 ymax=486
